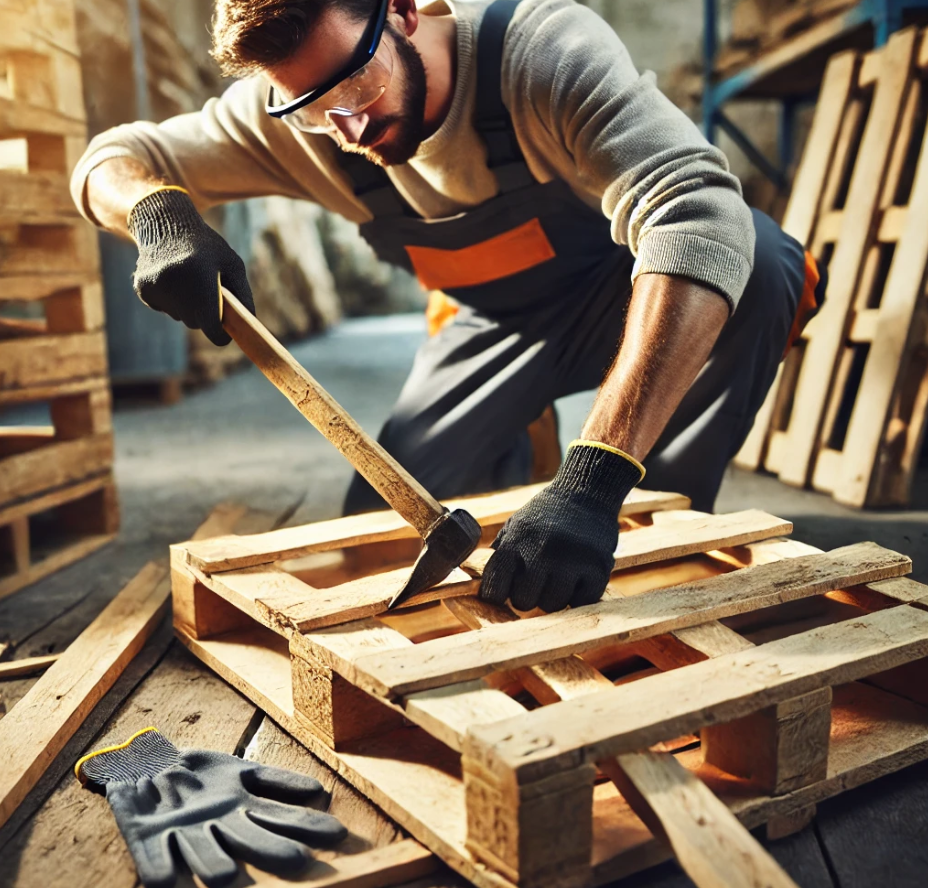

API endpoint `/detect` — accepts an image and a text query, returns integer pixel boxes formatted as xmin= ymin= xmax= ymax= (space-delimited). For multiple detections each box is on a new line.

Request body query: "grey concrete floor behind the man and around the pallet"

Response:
xmin=0 ymin=316 xmax=928 ymax=888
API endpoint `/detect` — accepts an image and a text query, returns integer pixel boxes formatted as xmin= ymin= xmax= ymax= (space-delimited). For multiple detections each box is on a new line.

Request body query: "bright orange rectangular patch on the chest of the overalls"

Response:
xmin=406 ymin=219 xmax=555 ymax=290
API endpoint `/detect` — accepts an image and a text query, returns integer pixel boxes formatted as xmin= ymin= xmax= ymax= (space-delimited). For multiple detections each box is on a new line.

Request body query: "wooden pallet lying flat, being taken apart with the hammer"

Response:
xmin=171 ymin=487 xmax=928 ymax=888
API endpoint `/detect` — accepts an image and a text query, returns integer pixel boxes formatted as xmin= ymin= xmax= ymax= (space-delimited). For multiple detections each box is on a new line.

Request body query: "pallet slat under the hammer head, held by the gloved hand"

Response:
xmin=201 ymin=511 xmax=792 ymax=635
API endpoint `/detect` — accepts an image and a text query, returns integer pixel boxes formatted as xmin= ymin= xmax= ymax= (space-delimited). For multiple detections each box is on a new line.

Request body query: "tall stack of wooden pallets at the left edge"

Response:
xmin=0 ymin=0 xmax=118 ymax=596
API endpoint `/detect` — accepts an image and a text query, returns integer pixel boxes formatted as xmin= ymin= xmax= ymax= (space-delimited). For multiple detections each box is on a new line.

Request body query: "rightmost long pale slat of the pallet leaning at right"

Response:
xmin=834 ymin=68 xmax=928 ymax=507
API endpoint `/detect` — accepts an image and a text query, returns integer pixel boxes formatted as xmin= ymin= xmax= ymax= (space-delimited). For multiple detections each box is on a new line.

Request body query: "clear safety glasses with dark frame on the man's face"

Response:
xmin=265 ymin=0 xmax=394 ymax=132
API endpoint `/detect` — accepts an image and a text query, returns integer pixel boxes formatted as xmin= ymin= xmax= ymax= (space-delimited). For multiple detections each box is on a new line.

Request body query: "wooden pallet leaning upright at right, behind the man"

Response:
xmin=735 ymin=28 xmax=928 ymax=507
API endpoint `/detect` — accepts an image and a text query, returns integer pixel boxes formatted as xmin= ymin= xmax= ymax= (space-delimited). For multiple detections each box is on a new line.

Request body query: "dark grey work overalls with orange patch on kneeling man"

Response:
xmin=344 ymin=0 xmax=805 ymax=514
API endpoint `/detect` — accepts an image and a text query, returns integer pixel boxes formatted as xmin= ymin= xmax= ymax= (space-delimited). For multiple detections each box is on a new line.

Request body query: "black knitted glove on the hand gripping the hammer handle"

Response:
xmin=128 ymin=188 xmax=255 ymax=345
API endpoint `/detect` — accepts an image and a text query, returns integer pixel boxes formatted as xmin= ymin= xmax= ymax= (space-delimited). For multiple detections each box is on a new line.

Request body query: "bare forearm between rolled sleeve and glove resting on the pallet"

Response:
xmin=582 ymin=274 xmax=729 ymax=460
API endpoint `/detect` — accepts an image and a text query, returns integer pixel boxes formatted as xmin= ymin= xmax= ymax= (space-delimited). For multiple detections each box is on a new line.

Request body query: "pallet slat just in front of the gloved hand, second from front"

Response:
xmin=330 ymin=543 xmax=911 ymax=696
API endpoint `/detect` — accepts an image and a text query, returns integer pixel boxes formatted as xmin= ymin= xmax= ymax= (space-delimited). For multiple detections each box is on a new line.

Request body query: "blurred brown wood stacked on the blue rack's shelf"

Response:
xmin=716 ymin=0 xmax=856 ymax=76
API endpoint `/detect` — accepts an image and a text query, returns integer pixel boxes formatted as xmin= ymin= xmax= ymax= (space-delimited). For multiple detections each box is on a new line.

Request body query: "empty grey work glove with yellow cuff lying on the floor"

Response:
xmin=75 ymin=728 xmax=347 ymax=888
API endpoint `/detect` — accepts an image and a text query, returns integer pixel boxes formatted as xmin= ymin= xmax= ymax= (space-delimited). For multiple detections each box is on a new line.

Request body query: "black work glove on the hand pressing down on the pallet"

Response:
xmin=480 ymin=441 xmax=644 ymax=613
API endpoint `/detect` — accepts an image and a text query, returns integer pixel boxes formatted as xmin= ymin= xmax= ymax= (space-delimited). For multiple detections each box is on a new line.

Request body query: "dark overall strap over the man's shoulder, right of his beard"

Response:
xmin=474 ymin=0 xmax=534 ymax=193
